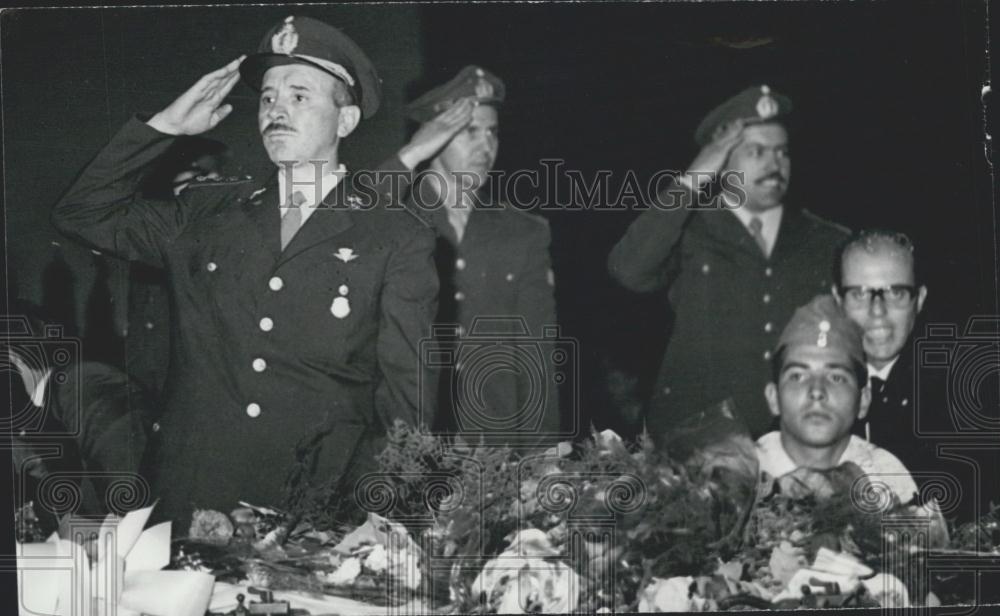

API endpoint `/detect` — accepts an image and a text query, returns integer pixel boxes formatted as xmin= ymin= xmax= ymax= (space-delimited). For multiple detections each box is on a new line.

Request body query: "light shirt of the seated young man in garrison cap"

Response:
xmin=757 ymin=430 xmax=917 ymax=503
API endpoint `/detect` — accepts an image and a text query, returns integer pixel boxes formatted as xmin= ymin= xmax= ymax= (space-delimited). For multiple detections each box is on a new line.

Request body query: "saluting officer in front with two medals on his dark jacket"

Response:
xmin=52 ymin=17 xmax=467 ymax=524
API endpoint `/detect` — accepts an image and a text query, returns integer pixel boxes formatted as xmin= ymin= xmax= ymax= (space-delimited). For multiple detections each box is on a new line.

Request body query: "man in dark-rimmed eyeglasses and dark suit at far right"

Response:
xmin=835 ymin=230 xmax=928 ymax=468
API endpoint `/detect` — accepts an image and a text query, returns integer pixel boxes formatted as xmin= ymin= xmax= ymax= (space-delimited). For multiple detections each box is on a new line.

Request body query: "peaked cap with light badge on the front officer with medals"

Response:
xmin=240 ymin=15 xmax=382 ymax=118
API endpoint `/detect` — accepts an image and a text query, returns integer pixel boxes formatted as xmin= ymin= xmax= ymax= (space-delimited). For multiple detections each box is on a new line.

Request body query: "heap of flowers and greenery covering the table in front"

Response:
xmin=168 ymin=407 xmax=1000 ymax=614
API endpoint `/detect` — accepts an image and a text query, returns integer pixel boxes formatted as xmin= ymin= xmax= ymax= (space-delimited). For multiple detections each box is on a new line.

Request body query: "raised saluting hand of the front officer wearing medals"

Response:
xmin=147 ymin=55 xmax=246 ymax=135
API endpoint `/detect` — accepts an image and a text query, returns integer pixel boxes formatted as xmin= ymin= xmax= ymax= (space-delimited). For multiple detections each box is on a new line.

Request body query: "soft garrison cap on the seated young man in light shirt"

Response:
xmin=777 ymin=295 xmax=865 ymax=365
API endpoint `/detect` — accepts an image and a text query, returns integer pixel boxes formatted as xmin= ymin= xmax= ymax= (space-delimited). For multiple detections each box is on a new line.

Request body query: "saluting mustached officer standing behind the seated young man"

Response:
xmin=609 ymin=86 xmax=847 ymax=439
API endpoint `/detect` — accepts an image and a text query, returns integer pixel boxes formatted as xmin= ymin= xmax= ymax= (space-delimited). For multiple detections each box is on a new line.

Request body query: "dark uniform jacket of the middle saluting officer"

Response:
xmin=408 ymin=181 xmax=560 ymax=444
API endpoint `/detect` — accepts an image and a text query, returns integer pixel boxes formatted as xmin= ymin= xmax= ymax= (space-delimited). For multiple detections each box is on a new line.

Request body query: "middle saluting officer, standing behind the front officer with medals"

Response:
xmin=408 ymin=66 xmax=560 ymax=446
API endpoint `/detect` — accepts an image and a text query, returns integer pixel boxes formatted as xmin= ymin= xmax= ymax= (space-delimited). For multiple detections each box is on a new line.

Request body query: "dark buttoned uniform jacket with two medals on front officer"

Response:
xmin=53 ymin=119 xmax=438 ymax=523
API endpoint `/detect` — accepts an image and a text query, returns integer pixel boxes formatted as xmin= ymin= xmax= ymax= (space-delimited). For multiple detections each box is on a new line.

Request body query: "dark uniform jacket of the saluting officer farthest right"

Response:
xmin=608 ymin=184 xmax=847 ymax=440
